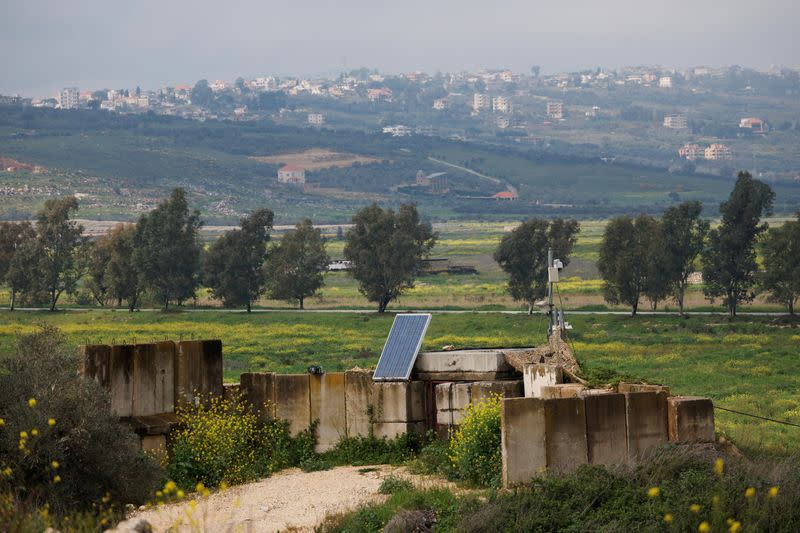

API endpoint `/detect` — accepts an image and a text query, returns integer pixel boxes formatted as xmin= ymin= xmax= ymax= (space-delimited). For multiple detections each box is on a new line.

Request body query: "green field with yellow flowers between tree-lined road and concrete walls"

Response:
xmin=0 ymin=311 xmax=800 ymax=453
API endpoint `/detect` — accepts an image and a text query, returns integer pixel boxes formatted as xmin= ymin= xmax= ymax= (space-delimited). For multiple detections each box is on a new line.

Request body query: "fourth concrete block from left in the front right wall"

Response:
xmin=625 ymin=391 xmax=668 ymax=461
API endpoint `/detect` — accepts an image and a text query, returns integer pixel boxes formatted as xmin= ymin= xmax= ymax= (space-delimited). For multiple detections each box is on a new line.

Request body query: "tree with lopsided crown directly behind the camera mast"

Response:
xmin=494 ymin=218 xmax=580 ymax=313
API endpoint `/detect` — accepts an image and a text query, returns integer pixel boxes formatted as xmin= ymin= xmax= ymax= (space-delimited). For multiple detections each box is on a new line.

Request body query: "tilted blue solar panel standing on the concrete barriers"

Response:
xmin=372 ymin=313 xmax=431 ymax=381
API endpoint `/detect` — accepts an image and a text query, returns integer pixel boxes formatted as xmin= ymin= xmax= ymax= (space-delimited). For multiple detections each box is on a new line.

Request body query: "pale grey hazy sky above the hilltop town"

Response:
xmin=0 ymin=0 xmax=800 ymax=96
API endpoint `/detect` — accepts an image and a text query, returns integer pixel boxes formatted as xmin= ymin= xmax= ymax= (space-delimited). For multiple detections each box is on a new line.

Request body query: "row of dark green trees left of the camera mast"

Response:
xmin=0 ymin=189 xmax=436 ymax=312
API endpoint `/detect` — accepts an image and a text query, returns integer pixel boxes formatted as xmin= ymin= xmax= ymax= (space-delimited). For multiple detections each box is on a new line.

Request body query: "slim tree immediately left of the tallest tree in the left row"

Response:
xmin=103 ymin=224 xmax=141 ymax=312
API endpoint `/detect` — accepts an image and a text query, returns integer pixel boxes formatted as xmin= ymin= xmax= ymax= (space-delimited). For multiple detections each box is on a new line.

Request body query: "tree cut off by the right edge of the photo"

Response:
xmin=761 ymin=212 xmax=800 ymax=315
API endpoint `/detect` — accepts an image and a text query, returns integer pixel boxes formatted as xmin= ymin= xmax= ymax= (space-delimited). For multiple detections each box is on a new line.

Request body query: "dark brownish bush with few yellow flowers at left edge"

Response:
xmin=0 ymin=327 xmax=163 ymax=520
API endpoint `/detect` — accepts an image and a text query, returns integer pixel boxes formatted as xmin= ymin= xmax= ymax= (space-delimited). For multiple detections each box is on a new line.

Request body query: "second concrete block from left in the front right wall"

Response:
xmin=542 ymin=397 xmax=589 ymax=472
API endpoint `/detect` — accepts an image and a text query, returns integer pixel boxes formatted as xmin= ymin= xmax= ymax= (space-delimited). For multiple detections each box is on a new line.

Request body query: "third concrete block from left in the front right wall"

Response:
xmin=584 ymin=394 xmax=628 ymax=466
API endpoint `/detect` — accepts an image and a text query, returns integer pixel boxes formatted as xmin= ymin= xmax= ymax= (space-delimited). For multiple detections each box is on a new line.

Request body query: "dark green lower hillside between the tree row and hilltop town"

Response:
xmin=0 ymin=106 xmax=800 ymax=223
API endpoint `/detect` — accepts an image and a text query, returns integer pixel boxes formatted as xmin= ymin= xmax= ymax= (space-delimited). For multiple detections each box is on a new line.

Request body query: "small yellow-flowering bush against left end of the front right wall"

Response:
xmin=448 ymin=396 xmax=502 ymax=487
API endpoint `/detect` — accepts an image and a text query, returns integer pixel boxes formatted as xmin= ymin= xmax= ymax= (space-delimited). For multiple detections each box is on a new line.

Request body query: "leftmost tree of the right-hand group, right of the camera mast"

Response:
xmin=597 ymin=215 xmax=656 ymax=316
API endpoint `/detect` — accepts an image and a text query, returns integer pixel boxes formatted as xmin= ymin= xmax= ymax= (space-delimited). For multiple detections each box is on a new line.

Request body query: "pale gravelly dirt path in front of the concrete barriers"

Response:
xmin=115 ymin=465 xmax=410 ymax=533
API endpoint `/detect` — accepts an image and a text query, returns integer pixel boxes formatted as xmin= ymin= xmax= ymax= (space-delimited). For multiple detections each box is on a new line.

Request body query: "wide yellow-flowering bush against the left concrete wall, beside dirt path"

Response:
xmin=167 ymin=392 xmax=304 ymax=489
